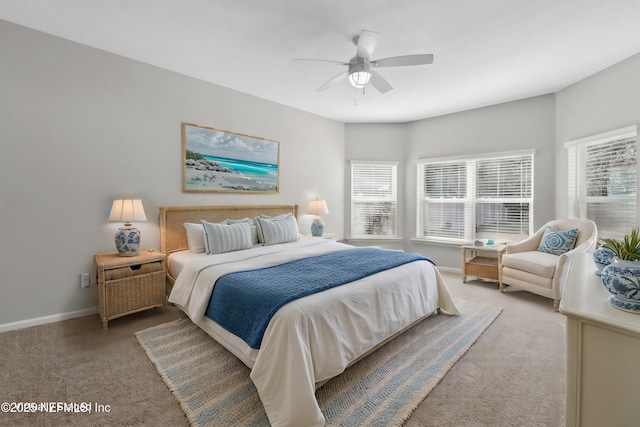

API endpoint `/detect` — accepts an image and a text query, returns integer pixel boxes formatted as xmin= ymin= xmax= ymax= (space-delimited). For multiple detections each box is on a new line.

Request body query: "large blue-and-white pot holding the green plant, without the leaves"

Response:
xmin=601 ymin=259 xmax=640 ymax=313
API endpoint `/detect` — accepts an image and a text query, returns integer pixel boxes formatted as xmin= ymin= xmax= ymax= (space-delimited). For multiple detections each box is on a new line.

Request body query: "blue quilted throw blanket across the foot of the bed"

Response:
xmin=205 ymin=248 xmax=433 ymax=349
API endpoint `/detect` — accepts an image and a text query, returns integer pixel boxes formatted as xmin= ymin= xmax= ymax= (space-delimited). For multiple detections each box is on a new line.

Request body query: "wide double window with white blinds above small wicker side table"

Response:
xmin=416 ymin=151 xmax=534 ymax=243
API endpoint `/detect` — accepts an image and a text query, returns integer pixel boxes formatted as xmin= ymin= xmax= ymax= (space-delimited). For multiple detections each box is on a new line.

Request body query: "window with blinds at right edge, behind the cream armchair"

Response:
xmin=565 ymin=126 xmax=638 ymax=238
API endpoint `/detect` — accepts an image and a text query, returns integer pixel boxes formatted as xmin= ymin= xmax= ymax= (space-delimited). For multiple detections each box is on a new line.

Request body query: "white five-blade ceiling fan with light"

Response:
xmin=293 ymin=30 xmax=433 ymax=93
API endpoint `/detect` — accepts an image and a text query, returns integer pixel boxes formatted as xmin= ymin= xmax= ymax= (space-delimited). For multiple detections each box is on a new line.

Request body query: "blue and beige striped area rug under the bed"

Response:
xmin=136 ymin=299 xmax=502 ymax=427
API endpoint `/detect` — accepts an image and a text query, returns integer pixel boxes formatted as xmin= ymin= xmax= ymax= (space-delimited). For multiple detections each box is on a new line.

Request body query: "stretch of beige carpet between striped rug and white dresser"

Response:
xmin=405 ymin=273 xmax=566 ymax=427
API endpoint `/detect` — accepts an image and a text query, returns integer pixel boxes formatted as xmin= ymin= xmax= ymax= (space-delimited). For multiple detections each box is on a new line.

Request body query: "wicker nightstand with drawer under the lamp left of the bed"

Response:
xmin=95 ymin=250 xmax=166 ymax=331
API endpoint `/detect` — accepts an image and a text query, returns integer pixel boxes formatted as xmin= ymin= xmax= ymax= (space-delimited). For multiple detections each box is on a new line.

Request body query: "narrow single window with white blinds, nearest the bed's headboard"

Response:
xmin=351 ymin=161 xmax=398 ymax=239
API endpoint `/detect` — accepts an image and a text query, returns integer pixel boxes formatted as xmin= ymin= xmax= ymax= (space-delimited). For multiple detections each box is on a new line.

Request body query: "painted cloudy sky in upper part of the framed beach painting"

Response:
xmin=186 ymin=125 xmax=279 ymax=164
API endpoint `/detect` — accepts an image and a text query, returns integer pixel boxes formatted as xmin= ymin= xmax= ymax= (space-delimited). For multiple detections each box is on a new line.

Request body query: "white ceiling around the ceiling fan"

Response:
xmin=0 ymin=0 xmax=640 ymax=123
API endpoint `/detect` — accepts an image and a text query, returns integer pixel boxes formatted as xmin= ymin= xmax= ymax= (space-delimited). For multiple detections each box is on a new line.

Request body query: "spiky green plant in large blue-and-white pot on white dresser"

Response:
xmin=601 ymin=228 xmax=640 ymax=313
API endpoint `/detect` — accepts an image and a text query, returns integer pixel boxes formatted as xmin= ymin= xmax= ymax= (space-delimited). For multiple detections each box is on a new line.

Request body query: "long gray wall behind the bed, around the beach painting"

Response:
xmin=0 ymin=21 xmax=345 ymax=330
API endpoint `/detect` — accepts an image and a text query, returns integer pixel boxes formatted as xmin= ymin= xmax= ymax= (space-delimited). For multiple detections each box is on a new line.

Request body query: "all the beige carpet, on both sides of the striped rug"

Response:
xmin=0 ymin=272 xmax=565 ymax=427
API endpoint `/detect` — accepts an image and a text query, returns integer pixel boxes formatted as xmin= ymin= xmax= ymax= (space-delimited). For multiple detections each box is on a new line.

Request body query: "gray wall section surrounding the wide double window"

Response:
xmin=405 ymin=95 xmax=555 ymax=268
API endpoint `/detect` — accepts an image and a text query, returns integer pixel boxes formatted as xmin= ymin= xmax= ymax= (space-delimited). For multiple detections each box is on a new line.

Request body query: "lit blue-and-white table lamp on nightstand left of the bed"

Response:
xmin=109 ymin=199 xmax=147 ymax=256
